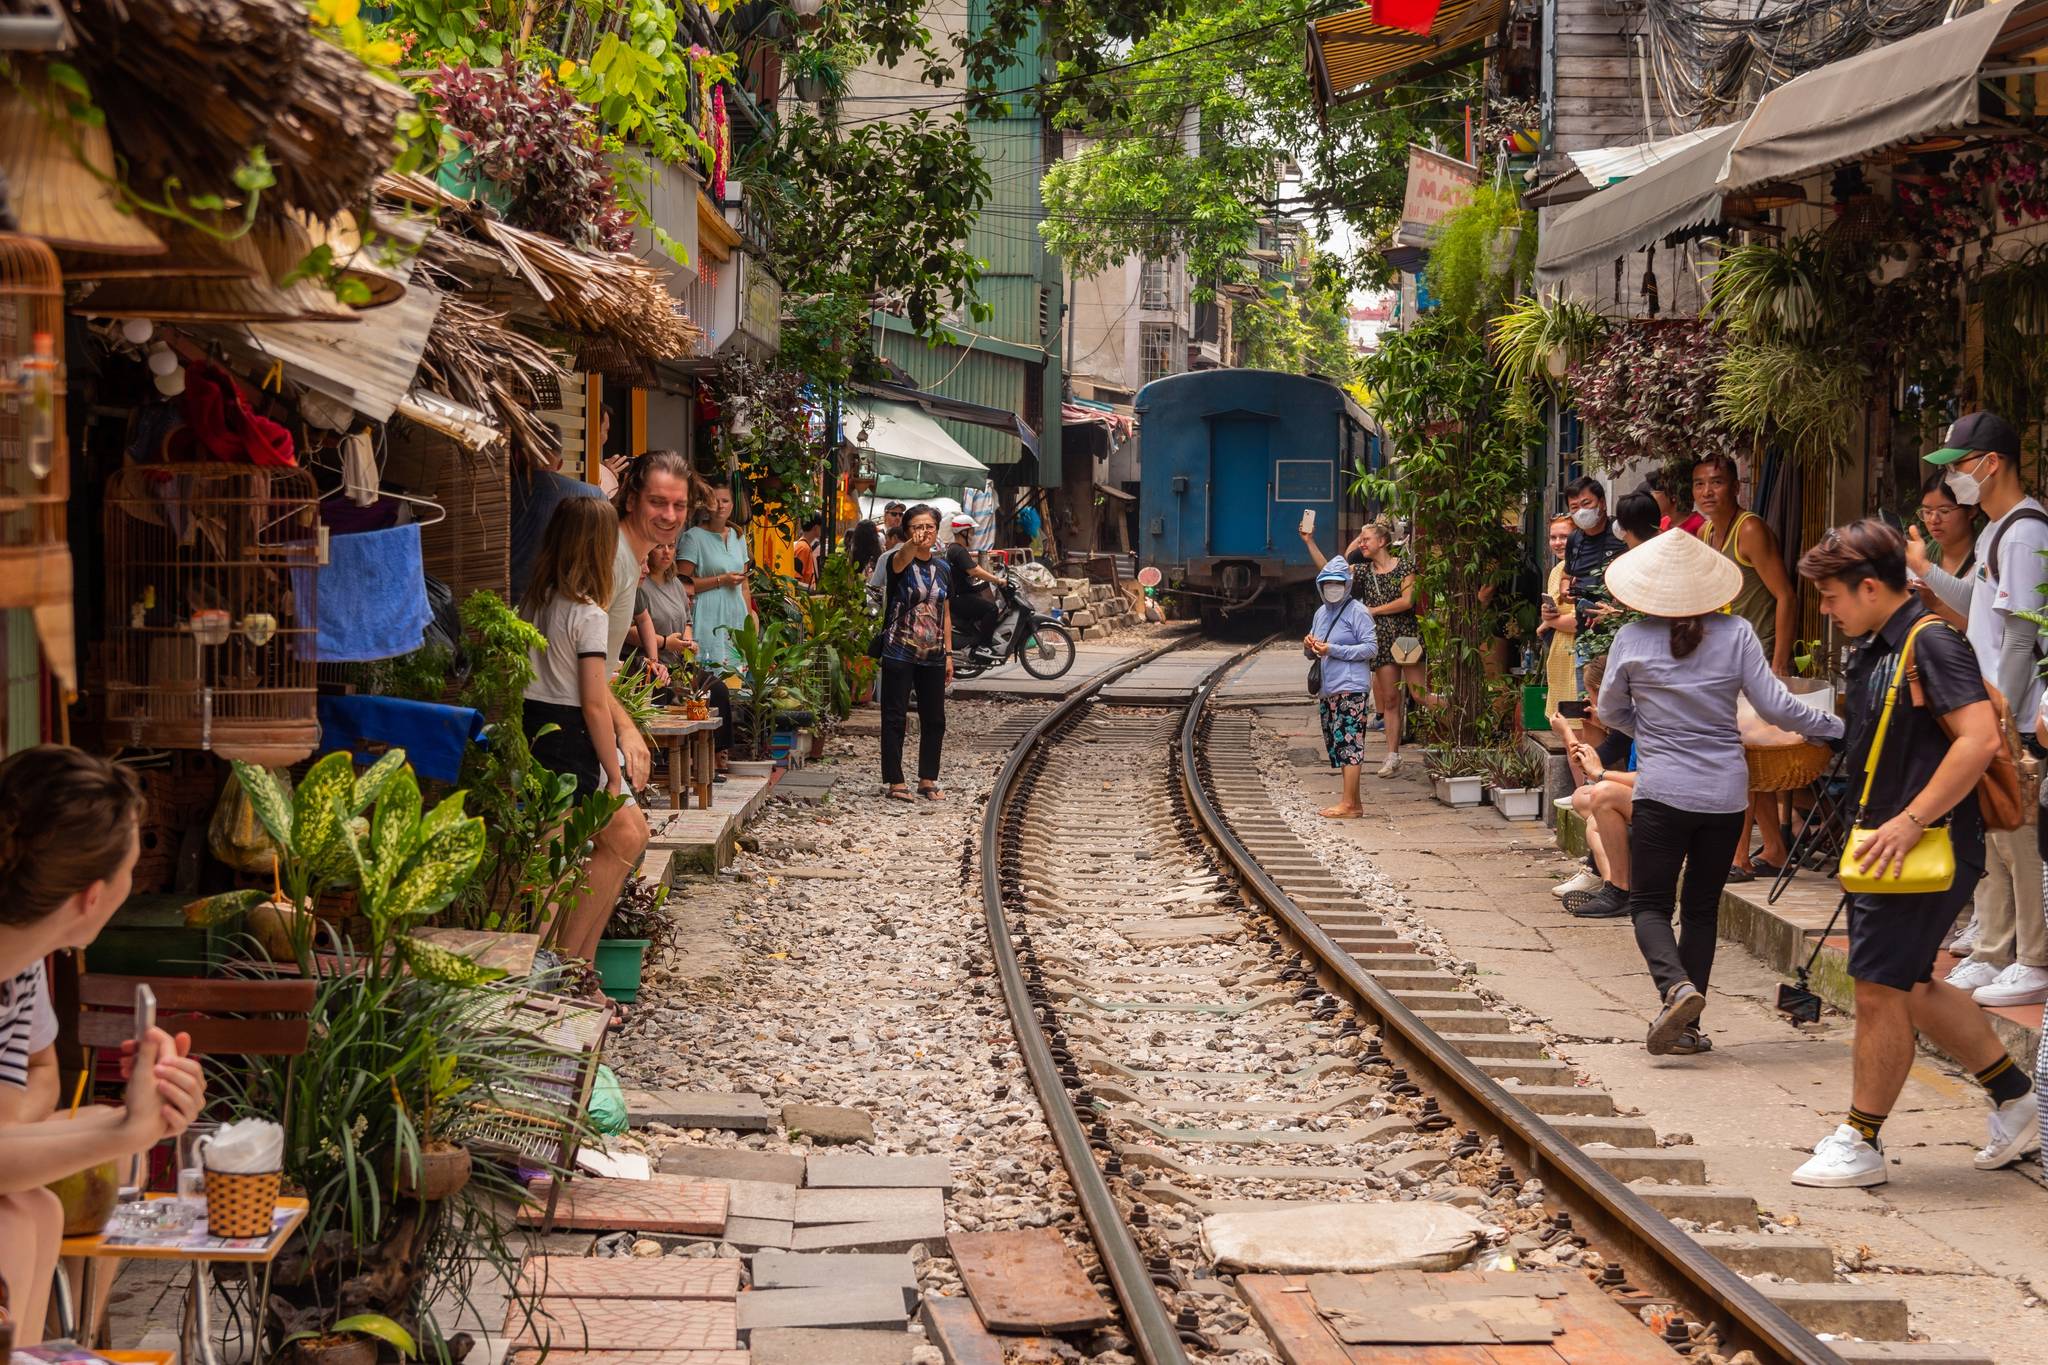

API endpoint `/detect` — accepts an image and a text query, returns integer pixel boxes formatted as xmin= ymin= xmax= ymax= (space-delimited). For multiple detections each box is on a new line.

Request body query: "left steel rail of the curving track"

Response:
xmin=981 ymin=636 xmax=1264 ymax=1365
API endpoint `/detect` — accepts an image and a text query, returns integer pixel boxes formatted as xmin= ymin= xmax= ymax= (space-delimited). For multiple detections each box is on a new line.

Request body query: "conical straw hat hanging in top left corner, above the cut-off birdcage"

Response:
xmin=0 ymin=53 xmax=164 ymax=256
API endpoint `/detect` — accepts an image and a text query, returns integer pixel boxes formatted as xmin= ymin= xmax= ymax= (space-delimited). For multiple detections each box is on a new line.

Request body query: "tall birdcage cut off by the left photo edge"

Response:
xmin=0 ymin=233 xmax=76 ymax=688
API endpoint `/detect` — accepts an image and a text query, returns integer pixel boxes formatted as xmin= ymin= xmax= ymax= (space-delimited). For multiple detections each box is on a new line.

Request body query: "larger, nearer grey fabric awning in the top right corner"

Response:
xmin=1718 ymin=0 xmax=2048 ymax=190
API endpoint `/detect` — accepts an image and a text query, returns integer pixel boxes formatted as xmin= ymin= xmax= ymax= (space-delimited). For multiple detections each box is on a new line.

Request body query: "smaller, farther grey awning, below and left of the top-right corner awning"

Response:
xmin=1536 ymin=123 xmax=1743 ymax=280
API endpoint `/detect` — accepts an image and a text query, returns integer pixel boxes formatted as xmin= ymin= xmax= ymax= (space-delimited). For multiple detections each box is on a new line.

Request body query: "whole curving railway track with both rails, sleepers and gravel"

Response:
xmin=981 ymin=645 xmax=1985 ymax=1365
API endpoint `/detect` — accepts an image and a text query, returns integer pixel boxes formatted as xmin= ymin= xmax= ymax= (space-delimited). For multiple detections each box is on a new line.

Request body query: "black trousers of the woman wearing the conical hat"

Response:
xmin=1628 ymin=798 xmax=1749 ymax=999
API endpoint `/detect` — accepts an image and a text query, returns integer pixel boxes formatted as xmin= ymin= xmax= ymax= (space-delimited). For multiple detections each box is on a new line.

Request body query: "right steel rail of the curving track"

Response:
xmin=1180 ymin=658 xmax=1843 ymax=1365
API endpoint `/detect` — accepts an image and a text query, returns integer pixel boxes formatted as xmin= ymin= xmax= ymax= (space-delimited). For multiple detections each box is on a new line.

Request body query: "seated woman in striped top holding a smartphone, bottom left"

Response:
xmin=0 ymin=745 xmax=207 ymax=1349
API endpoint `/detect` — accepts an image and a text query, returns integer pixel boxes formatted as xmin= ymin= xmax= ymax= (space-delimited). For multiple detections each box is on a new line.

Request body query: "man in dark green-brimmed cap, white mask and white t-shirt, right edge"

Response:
xmin=1907 ymin=411 xmax=2048 ymax=1007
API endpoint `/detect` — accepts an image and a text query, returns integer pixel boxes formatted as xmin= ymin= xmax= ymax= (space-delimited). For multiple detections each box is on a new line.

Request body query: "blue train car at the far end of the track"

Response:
xmin=1137 ymin=370 xmax=1378 ymax=616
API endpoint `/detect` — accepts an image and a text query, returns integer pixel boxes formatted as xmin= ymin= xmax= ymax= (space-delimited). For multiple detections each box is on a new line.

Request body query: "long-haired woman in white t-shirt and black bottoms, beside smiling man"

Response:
xmin=520 ymin=497 xmax=627 ymax=806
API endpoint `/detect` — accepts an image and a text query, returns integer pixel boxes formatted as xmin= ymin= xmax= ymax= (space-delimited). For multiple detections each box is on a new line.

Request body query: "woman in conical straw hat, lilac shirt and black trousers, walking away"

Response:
xmin=1599 ymin=532 xmax=1841 ymax=1054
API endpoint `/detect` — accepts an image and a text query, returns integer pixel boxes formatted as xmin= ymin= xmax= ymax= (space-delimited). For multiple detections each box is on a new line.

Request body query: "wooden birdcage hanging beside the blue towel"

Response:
xmin=106 ymin=463 xmax=322 ymax=765
